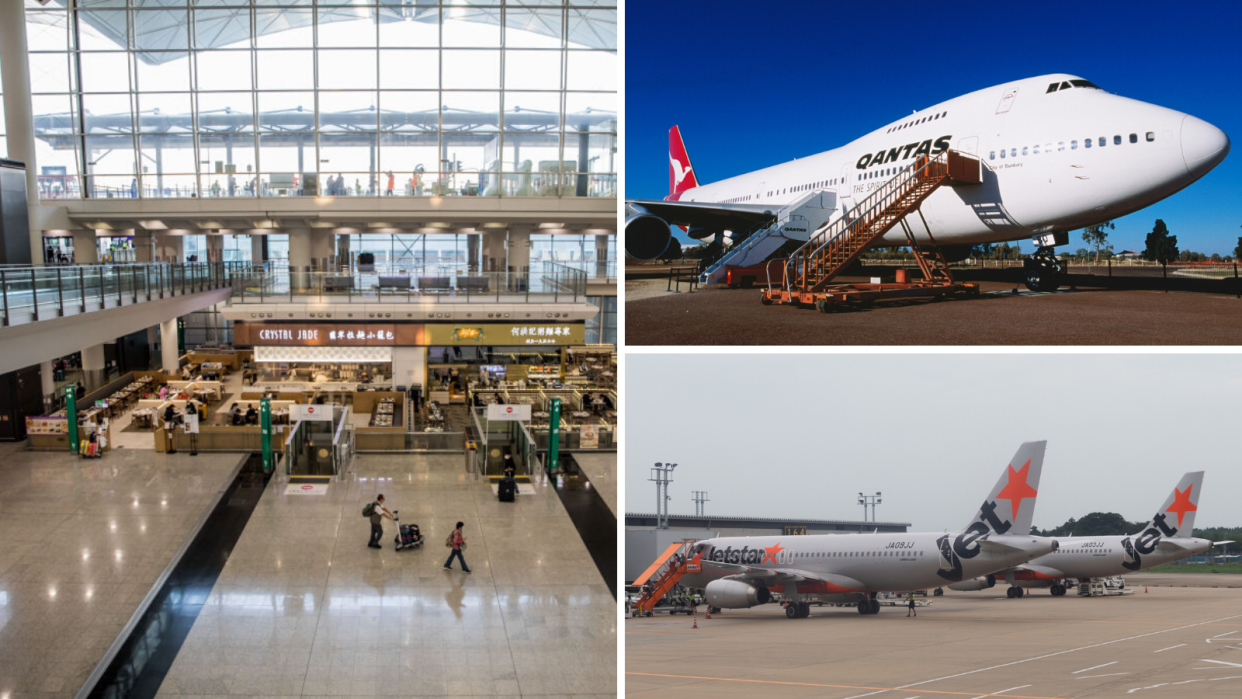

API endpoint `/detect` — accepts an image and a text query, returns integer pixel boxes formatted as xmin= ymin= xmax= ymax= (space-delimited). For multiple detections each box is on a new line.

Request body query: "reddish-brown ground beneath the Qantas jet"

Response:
xmin=625 ymin=278 xmax=1242 ymax=345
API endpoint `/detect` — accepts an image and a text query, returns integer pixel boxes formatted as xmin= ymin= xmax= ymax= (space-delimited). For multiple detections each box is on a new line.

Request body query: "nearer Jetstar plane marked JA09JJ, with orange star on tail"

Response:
xmin=681 ymin=442 xmax=1057 ymax=618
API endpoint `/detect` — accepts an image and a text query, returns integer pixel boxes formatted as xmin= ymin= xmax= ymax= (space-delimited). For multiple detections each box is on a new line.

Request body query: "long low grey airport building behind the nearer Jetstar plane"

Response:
xmin=625 ymin=513 xmax=910 ymax=582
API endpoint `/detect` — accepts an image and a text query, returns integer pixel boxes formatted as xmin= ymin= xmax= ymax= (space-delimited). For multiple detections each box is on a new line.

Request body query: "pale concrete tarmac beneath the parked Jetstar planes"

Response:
xmin=625 ymin=586 xmax=1242 ymax=699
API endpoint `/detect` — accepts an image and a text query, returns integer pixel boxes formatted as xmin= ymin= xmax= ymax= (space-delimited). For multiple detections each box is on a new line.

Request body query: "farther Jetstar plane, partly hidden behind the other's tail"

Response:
xmin=949 ymin=471 xmax=1232 ymax=597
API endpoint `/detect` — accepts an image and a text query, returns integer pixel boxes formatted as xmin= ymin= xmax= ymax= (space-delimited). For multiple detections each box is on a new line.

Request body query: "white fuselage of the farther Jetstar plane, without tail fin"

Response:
xmin=1006 ymin=535 xmax=1212 ymax=587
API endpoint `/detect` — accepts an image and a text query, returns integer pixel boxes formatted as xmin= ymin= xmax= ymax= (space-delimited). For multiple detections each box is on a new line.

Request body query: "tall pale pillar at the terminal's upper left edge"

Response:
xmin=0 ymin=1 xmax=43 ymax=264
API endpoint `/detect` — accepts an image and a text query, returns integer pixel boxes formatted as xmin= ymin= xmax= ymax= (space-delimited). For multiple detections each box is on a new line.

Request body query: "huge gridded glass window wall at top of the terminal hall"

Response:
xmin=21 ymin=0 xmax=617 ymax=199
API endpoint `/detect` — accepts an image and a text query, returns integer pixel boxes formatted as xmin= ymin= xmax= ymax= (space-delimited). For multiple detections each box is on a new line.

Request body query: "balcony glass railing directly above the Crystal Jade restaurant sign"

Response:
xmin=232 ymin=264 xmax=586 ymax=303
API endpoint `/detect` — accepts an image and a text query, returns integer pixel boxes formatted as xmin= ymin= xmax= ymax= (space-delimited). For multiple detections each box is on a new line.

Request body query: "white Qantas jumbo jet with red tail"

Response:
xmin=625 ymin=73 xmax=1230 ymax=289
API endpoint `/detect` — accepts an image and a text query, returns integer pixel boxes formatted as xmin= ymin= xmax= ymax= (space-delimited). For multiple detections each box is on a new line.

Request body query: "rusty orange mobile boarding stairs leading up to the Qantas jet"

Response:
xmin=760 ymin=150 xmax=982 ymax=313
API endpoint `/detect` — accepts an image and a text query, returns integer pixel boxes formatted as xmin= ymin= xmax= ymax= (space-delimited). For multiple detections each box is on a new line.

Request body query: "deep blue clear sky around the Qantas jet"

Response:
xmin=625 ymin=0 xmax=1242 ymax=255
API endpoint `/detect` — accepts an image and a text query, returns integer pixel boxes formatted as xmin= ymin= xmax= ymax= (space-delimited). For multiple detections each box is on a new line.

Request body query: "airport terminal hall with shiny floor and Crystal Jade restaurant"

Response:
xmin=0 ymin=0 xmax=620 ymax=699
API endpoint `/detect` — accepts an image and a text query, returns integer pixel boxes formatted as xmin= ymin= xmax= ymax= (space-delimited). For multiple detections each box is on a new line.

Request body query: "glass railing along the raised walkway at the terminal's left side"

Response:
xmin=0 ymin=262 xmax=255 ymax=325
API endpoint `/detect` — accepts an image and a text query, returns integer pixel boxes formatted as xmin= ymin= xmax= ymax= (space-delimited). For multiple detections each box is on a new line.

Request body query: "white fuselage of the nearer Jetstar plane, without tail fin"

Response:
xmin=681 ymin=533 xmax=1056 ymax=598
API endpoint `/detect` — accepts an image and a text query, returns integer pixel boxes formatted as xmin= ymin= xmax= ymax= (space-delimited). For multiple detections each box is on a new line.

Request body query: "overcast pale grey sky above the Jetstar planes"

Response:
xmin=625 ymin=353 xmax=1242 ymax=531
